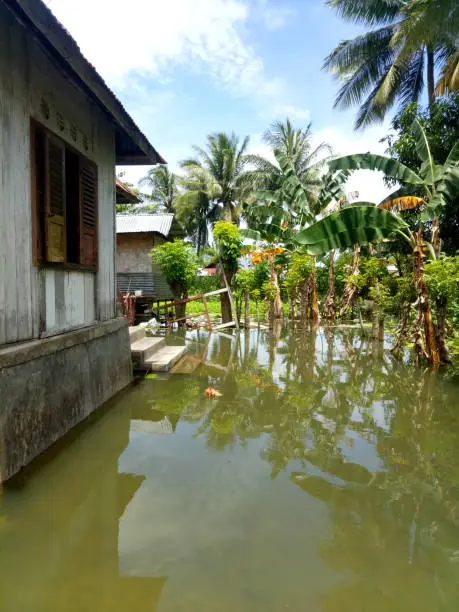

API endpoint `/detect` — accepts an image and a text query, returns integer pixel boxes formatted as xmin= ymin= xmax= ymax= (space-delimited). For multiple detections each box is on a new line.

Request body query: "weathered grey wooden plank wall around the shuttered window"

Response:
xmin=0 ymin=2 xmax=115 ymax=345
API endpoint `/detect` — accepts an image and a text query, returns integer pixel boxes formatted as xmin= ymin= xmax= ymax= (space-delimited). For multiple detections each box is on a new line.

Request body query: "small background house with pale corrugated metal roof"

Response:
xmin=116 ymin=213 xmax=184 ymax=302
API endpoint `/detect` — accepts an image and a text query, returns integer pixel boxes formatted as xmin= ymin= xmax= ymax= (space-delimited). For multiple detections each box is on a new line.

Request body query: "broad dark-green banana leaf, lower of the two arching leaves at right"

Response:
xmin=295 ymin=202 xmax=409 ymax=255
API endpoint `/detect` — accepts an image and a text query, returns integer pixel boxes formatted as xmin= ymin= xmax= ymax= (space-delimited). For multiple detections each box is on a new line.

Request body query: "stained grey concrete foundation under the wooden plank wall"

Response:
xmin=0 ymin=319 xmax=132 ymax=482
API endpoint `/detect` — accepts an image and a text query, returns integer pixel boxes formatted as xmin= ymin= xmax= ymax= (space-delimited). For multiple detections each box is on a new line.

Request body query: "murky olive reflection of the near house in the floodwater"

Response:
xmin=0 ymin=406 xmax=167 ymax=612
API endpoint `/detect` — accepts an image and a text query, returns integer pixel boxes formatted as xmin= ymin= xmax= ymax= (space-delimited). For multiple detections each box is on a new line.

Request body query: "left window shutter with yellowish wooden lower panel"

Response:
xmin=45 ymin=136 xmax=66 ymax=262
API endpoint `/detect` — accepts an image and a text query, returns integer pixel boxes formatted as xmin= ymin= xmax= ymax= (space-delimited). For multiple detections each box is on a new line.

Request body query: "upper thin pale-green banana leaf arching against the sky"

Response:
xmin=328 ymin=153 xmax=424 ymax=185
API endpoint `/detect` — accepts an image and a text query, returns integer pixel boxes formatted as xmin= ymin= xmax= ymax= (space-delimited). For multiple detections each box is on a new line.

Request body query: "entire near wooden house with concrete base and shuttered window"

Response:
xmin=0 ymin=0 xmax=165 ymax=480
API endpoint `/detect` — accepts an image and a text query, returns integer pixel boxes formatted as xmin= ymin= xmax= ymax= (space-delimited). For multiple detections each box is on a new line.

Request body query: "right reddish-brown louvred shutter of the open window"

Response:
xmin=80 ymin=158 xmax=98 ymax=266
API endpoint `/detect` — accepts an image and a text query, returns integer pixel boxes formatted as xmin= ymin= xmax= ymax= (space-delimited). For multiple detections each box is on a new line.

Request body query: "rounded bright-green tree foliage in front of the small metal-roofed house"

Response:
xmin=151 ymin=240 xmax=198 ymax=290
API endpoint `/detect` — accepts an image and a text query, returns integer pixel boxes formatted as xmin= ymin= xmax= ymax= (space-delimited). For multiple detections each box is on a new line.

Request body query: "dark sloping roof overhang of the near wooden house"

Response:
xmin=4 ymin=0 xmax=166 ymax=165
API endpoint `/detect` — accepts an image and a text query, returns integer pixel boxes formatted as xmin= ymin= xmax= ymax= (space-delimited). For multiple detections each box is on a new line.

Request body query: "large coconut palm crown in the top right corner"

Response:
xmin=324 ymin=0 xmax=459 ymax=129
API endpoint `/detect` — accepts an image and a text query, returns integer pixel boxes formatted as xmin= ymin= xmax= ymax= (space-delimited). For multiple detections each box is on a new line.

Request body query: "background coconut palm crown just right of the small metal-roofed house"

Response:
xmin=180 ymin=132 xmax=249 ymax=223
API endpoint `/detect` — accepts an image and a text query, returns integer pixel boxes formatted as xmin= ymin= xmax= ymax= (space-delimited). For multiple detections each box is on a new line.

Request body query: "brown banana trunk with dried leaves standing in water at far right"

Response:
xmin=413 ymin=230 xmax=440 ymax=368
